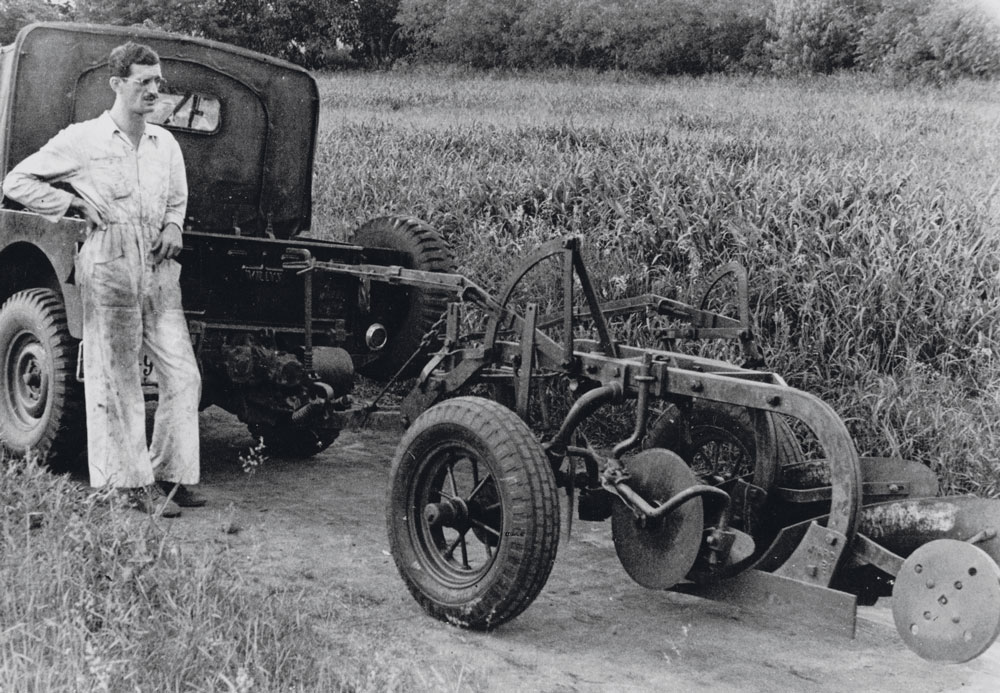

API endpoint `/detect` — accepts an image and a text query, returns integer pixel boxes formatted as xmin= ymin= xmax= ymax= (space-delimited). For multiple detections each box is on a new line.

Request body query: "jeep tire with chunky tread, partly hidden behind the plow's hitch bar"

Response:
xmin=352 ymin=217 xmax=455 ymax=381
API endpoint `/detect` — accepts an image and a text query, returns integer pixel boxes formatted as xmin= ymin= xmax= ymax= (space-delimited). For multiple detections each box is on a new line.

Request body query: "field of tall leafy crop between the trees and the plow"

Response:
xmin=313 ymin=69 xmax=1000 ymax=496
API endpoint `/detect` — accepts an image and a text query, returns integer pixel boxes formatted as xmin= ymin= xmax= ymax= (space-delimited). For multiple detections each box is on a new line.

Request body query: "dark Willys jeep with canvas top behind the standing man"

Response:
xmin=0 ymin=23 xmax=452 ymax=462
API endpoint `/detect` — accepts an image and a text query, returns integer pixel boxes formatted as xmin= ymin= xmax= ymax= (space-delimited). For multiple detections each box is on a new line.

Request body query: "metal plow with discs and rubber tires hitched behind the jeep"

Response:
xmin=286 ymin=238 xmax=1000 ymax=662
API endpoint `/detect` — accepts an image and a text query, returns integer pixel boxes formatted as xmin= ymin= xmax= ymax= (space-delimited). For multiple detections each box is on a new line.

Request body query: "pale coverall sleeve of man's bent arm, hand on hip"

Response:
xmin=3 ymin=125 xmax=83 ymax=222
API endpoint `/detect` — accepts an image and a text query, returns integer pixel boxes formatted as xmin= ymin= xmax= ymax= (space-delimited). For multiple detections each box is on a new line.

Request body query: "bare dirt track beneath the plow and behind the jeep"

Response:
xmin=172 ymin=409 xmax=1000 ymax=693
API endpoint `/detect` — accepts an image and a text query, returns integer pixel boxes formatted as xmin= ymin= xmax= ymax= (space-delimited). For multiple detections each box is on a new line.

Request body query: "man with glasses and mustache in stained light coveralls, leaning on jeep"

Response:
xmin=3 ymin=42 xmax=205 ymax=517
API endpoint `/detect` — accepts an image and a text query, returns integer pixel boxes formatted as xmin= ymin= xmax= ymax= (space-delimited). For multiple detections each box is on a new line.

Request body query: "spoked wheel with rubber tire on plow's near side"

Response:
xmin=387 ymin=397 xmax=559 ymax=630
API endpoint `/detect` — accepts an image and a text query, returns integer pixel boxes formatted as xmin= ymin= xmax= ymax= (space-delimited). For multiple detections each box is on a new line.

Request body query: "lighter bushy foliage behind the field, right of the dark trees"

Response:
xmin=396 ymin=0 xmax=1000 ymax=80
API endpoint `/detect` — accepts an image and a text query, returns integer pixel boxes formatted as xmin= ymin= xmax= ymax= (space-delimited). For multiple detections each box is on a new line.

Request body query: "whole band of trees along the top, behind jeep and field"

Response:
xmin=0 ymin=0 xmax=1000 ymax=82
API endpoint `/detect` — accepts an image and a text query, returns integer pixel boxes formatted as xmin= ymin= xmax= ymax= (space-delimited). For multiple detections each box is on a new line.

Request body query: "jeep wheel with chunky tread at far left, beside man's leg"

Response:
xmin=0 ymin=289 xmax=86 ymax=467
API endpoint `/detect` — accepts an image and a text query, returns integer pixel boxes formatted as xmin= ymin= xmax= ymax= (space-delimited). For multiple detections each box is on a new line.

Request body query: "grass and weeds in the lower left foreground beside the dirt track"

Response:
xmin=0 ymin=452 xmax=473 ymax=693
